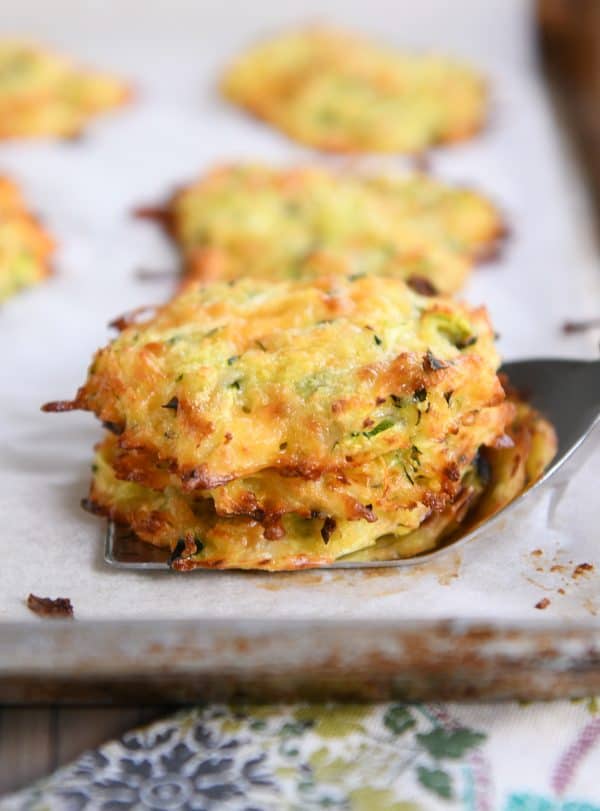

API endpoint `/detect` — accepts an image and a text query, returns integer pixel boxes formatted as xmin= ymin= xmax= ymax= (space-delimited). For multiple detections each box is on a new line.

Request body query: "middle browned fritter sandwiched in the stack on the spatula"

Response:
xmin=111 ymin=400 xmax=513 ymax=531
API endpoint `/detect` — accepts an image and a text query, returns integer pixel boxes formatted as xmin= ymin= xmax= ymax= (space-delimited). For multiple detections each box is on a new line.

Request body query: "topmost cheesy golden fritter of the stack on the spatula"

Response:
xmin=72 ymin=277 xmax=507 ymax=498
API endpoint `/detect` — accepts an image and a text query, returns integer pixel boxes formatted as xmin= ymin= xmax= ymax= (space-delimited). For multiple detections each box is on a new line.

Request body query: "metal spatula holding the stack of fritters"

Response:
xmin=104 ymin=359 xmax=600 ymax=571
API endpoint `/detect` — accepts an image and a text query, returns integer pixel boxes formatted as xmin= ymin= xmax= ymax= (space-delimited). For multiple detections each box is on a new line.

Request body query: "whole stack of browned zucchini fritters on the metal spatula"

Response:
xmin=45 ymin=276 xmax=555 ymax=570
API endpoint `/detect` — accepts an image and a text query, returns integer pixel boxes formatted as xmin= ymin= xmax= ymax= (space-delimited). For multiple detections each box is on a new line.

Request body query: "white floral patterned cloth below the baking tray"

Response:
xmin=0 ymin=700 xmax=600 ymax=811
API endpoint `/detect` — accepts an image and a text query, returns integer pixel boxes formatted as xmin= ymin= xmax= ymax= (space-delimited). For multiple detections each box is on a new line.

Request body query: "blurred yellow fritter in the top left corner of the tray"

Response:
xmin=0 ymin=40 xmax=130 ymax=138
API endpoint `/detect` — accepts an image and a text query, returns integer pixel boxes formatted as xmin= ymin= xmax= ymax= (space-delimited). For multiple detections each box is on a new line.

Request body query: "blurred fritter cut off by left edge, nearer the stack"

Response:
xmin=0 ymin=177 xmax=54 ymax=302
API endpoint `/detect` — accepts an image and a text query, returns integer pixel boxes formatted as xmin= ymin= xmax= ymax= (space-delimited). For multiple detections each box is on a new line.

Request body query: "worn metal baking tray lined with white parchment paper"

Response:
xmin=0 ymin=0 xmax=600 ymax=702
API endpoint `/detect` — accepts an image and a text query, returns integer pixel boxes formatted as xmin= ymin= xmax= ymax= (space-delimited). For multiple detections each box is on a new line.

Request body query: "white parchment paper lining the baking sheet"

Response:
xmin=0 ymin=0 xmax=600 ymax=628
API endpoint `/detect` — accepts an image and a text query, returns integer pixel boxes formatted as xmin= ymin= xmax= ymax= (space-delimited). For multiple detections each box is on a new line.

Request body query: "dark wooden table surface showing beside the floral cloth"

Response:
xmin=0 ymin=706 xmax=175 ymax=797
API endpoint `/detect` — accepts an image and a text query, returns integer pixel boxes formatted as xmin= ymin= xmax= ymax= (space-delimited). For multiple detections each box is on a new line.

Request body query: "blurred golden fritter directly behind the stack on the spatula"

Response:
xmin=149 ymin=165 xmax=504 ymax=293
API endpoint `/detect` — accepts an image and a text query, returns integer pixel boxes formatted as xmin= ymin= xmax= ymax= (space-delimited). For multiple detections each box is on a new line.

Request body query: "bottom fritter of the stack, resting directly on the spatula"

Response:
xmin=90 ymin=403 xmax=556 ymax=571
